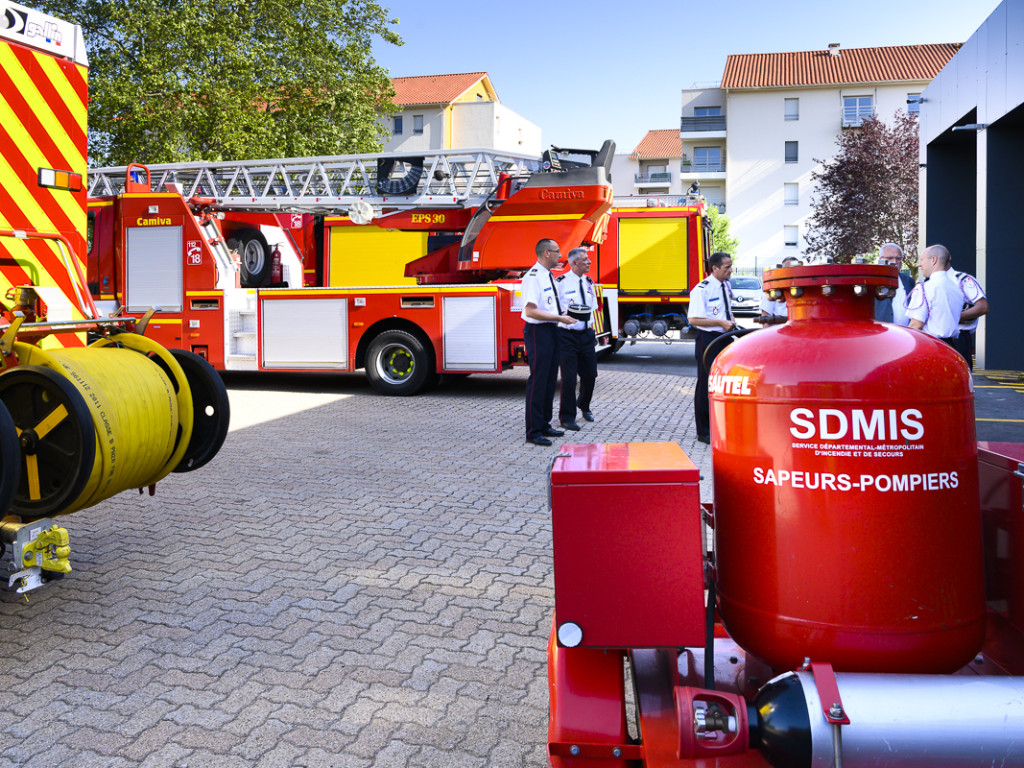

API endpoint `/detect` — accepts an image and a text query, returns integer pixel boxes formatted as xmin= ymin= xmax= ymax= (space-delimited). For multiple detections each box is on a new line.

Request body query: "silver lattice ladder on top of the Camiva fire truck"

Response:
xmin=88 ymin=150 xmax=541 ymax=215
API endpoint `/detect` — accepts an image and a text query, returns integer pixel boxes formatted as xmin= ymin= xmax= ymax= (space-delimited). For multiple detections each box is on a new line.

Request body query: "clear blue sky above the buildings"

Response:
xmin=374 ymin=0 xmax=999 ymax=152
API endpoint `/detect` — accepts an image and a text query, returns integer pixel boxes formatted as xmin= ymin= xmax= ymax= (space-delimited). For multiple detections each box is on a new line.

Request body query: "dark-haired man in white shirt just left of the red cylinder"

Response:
xmin=687 ymin=252 xmax=737 ymax=443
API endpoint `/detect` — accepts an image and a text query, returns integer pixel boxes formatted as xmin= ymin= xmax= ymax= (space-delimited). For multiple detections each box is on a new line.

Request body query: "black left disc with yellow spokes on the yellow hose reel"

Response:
xmin=0 ymin=366 xmax=96 ymax=520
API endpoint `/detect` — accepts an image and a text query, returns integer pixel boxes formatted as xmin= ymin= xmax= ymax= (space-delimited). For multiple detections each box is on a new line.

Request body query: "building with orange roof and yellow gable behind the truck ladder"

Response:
xmin=384 ymin=72 xmax=542 ymax=156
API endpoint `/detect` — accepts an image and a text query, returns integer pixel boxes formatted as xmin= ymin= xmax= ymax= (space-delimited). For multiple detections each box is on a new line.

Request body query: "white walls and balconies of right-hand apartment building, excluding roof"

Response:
xmin=681 ymin=70 xmax=928 ymax=272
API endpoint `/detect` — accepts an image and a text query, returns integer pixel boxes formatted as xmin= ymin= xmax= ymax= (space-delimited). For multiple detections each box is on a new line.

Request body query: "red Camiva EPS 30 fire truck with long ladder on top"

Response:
xmin=87 ymin=141 xmax=614 ymax=395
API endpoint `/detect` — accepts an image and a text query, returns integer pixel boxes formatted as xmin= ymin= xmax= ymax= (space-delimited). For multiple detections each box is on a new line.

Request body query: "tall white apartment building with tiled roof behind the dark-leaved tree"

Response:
xmin=680 ymin=43 xmax=961 ymax=272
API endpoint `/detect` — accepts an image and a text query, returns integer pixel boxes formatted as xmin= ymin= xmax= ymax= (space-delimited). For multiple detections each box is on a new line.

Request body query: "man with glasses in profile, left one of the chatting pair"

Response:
xmin=522 ymin=239 xmax=575 ymax=445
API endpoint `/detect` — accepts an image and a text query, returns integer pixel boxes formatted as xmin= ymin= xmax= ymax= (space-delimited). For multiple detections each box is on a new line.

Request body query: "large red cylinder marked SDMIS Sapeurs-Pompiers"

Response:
xmin=709 ymin=264 xmax=985 ymax=673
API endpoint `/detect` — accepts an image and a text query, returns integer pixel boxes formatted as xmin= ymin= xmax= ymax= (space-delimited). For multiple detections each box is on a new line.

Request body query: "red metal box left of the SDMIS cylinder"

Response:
xmin=551 ymin=442 xmax=705 ymax=648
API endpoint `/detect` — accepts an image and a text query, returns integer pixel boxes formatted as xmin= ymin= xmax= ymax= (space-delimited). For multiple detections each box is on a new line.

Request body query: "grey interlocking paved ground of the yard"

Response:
xmin=0 ymin=370 xmax=710 ymax=768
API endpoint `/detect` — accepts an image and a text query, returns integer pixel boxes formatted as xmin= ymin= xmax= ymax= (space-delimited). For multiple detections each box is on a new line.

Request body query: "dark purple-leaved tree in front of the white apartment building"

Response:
xmin=807 ymin=112 xmax=919 ymax=263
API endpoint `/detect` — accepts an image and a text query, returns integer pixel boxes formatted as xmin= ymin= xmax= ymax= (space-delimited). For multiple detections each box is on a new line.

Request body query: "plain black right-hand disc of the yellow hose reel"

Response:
xmin=167 ymin=349 xmax=231 ymax=472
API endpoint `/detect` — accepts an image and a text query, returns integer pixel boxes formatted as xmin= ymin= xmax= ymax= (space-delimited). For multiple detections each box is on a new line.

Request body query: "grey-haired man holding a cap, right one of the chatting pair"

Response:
xmin=555 ymin=248 xmax=597 ymax=431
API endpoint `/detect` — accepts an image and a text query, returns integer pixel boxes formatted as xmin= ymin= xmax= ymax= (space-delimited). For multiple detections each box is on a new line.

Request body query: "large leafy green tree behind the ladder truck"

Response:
xmin=46 ymin=0 xmax=401 ymax=165
